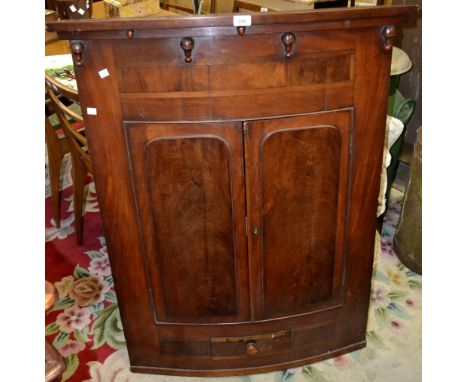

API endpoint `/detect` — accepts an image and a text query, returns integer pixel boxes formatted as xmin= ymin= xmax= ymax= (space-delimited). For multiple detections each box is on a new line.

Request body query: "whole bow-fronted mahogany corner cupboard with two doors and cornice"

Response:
xmin=48 ymin=6 xmax=416 ymax=376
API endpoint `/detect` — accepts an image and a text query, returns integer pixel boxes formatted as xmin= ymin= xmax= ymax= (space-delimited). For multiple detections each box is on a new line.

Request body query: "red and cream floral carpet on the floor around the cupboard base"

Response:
xmin=45 ymin=178 xmax=421 ymax=382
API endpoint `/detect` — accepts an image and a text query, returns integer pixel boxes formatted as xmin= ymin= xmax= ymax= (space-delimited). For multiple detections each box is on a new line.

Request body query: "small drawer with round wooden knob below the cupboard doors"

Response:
xmin=211 ymin=330 xmax=291 ymax=360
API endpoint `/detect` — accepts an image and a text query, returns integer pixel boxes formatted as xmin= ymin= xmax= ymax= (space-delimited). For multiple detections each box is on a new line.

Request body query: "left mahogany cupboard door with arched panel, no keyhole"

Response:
xmin=125 ymin=122 xmax=249 ymax=324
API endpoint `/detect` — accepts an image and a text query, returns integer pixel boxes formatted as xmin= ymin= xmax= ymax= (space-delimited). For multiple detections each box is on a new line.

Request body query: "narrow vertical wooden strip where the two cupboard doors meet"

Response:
xmin=242 ymin=121 xmax=255 ymax=321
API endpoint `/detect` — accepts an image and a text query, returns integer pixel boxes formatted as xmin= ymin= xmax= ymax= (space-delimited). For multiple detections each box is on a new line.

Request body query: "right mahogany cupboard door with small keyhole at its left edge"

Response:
xmin=244 ymin=110 xmax=352 ymax=320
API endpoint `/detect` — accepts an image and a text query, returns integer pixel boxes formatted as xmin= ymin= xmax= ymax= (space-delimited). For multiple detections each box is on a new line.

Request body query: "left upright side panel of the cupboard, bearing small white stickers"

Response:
xmin=71 ymin=40 xmax=159 ymax=364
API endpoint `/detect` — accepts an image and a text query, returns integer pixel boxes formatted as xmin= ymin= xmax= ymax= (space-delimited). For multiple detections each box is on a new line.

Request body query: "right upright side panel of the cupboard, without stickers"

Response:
xmin=340 ymin=28 xmax=391 ymax=343
